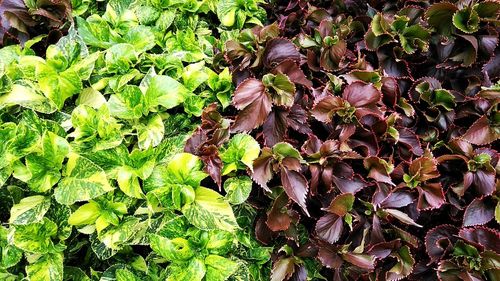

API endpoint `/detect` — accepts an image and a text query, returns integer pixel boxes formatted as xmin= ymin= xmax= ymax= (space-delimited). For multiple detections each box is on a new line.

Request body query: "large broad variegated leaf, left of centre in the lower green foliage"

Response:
xmin=54 ymin=153 xmax=113 ymax=205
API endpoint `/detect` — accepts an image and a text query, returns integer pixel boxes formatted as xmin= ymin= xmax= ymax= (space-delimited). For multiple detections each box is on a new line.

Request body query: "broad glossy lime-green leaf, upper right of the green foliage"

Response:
xmin=146 ymin=75 xmax=189 ymax=109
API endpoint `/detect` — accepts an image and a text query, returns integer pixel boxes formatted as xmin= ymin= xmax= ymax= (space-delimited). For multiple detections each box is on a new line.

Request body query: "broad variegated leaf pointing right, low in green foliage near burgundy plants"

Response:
xmin=182 ymin=187 xmax=238 ymax=232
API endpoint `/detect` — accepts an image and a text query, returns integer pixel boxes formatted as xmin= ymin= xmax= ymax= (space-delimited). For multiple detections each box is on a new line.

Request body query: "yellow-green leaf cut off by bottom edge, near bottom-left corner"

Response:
xmin=26 ymin=253 xmax=64 ymax=281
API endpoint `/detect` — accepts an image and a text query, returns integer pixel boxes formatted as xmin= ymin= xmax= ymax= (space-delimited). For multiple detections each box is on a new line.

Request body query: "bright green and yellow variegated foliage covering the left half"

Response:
xmin=0 ymin=1 xmax=270 ymax=281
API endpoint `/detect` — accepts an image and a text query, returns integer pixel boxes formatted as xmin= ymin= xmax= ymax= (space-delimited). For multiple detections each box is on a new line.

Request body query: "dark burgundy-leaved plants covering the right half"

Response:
xmin=200 ymin=1 xmax=500 ymax=280
